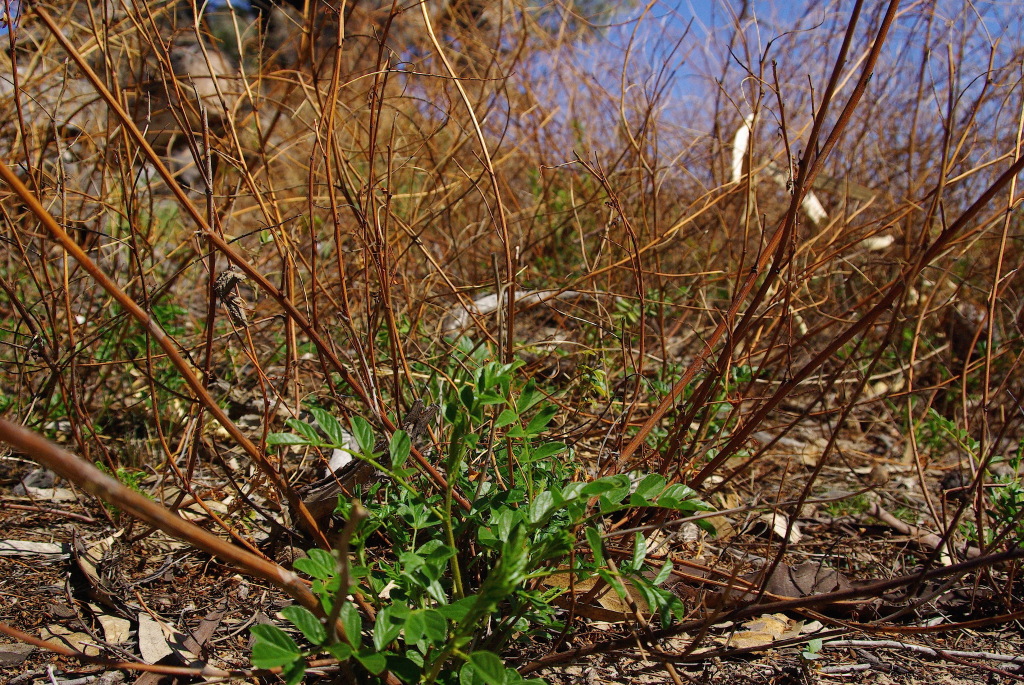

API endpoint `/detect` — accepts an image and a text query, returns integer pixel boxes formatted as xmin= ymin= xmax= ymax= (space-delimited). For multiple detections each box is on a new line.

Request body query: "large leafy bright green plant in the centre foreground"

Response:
xmin=253 ymin=349 xmax=710 ymax=684
